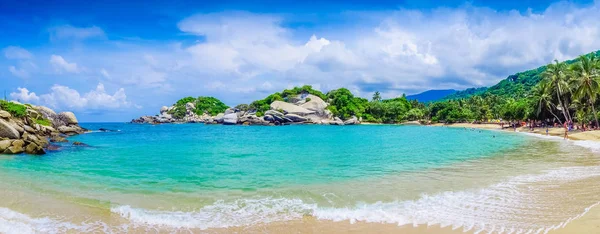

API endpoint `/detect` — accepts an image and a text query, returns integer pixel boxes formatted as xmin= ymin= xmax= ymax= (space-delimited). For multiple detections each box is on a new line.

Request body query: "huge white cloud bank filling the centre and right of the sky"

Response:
xmin=165 ymin=3 xmax=600 ymax=96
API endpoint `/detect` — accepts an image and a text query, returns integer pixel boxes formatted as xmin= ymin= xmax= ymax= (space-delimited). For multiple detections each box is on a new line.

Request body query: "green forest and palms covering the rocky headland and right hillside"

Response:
xmin=172 ymin=51 xmax=600 ymax=126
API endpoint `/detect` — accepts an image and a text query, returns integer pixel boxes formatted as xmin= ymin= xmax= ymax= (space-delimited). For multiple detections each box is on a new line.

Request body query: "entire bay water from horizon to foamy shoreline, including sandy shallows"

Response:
xmin=0 ymin=124 xmax=600 ymax=233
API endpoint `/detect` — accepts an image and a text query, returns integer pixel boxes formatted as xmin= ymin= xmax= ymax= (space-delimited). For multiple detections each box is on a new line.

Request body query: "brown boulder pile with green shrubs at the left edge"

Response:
xmin=0 ymin=103 xmax=86 ymax=155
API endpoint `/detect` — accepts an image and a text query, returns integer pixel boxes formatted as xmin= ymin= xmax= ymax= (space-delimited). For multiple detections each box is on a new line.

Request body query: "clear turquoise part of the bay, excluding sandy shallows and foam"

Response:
xmin=0 ymin=124 xmax=523 ymax=193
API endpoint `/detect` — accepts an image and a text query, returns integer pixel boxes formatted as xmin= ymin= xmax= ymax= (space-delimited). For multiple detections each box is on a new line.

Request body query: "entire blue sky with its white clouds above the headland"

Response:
xmin=0 ymin=0 xmax=600 ymax=121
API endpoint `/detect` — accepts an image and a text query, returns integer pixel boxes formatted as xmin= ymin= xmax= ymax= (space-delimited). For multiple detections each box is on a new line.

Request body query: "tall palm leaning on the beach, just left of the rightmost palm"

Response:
xmin=542 ymin=59 xmax=570 ymax=121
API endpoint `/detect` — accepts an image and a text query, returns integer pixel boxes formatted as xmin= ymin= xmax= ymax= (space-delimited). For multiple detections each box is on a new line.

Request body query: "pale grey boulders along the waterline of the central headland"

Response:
xmin=131 ymin=94 xmax=360 ymax=125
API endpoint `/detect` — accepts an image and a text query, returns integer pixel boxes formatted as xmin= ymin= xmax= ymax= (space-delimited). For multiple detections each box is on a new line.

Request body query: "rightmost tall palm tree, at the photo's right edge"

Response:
xmin=570 ymin=55 xmax=600 ymax=126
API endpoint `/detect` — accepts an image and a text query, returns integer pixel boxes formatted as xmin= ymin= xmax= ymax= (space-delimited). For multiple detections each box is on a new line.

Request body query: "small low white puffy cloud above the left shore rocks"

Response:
xmin=40 ymin=83 xmax=134 ymax=110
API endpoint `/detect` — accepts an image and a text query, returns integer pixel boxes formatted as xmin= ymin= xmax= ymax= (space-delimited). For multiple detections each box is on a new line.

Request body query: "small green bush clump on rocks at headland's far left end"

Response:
xmin=169 ymin=96 xmax=229 ymax=119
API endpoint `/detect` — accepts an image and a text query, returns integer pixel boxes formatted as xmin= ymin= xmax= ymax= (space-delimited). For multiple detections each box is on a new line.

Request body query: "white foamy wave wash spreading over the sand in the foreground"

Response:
xmin=111 ymin=167 xmax=600 ymax=233
